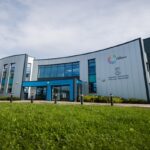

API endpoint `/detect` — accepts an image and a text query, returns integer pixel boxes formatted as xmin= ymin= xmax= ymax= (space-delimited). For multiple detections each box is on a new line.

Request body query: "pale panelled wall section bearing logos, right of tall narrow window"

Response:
xmin=96 ymin=40 xmax=147 ymax=99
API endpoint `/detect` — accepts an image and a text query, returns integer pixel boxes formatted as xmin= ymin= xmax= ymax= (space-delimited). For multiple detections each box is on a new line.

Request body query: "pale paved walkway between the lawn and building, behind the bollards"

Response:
xmin=0 ymin=100 xmax=150 ymax=108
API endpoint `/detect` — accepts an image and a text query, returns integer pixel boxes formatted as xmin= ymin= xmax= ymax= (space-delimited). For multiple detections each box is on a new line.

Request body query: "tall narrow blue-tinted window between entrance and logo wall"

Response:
xmin=88 ymin=59 xmax=96 ymax=93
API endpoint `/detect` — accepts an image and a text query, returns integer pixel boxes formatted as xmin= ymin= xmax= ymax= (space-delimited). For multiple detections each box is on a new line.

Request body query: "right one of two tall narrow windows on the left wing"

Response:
xmin=7 ymin=63 xmax=15 ymax=93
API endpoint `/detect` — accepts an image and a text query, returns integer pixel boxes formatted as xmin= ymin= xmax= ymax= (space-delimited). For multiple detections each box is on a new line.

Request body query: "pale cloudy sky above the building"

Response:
xmin=0 ymin=0 xmax=150 ymax=58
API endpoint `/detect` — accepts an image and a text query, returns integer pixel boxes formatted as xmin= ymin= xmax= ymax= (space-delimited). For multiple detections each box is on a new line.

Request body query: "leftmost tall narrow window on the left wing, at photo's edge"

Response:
xmin=1 ymin=64 xmax=8 ymax=93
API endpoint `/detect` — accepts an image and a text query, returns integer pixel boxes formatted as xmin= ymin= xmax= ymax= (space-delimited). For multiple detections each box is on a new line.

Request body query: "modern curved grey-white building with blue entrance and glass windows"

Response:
xmin=0 ymin=38 xmax=150 ymax=101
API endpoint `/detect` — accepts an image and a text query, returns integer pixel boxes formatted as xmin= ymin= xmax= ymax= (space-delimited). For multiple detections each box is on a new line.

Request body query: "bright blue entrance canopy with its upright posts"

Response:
xmin=22 ymin=79 xmax=76 ymax=101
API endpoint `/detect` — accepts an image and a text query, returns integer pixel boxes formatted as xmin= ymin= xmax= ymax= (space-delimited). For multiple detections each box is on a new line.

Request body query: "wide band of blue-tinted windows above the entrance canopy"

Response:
xmin=38 ymin=62 xmax=79 ymax=78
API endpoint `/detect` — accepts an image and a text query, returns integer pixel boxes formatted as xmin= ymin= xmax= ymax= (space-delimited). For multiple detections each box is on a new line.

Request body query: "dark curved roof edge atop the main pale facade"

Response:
xmin=35 ymin=38 xmax=141 ymax=61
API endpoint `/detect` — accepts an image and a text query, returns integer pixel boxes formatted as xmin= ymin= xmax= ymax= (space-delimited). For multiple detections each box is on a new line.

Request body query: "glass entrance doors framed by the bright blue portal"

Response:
xmin=52 ymin=86 xmax=70 ymax=101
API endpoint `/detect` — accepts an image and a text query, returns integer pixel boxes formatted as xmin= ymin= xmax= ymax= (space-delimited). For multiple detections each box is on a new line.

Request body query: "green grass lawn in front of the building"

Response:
xmin=0 ymin=103 xmax=150 ymax=150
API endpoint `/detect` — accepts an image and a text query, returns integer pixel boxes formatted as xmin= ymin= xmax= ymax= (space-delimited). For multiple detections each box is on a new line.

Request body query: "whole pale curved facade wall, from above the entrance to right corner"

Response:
xmin=32 ymin=39 xmax=147 ymax=100
